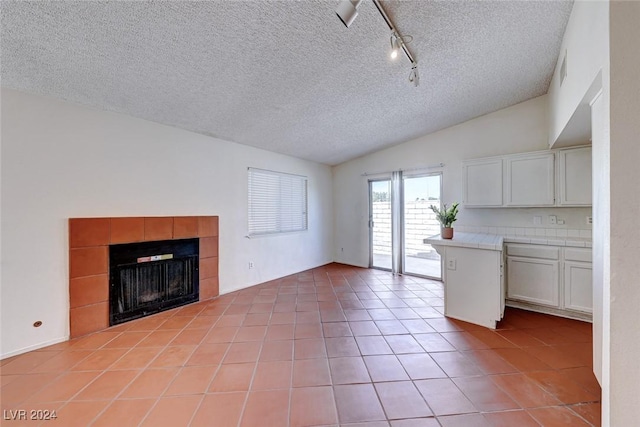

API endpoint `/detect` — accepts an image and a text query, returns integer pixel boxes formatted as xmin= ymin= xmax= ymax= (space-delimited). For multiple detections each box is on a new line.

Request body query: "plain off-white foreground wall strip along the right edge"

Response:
xmin=603 ymin=1 xmax=640 ymax=426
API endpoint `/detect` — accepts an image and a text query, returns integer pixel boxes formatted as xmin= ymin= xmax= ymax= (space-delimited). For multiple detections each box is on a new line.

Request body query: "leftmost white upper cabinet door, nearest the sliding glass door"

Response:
xmin=463 ymin=159 xmax=502 ymax=207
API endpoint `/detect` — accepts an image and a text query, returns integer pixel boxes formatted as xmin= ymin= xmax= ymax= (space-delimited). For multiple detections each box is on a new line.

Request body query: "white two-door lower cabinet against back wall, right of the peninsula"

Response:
xmin=506 ymin=244 xmax=593 ymax=318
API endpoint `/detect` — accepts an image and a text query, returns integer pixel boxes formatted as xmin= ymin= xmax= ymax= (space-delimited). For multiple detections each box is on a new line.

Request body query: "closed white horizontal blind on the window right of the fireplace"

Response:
xmin=249 ymin=168 xmax=307 ymax=236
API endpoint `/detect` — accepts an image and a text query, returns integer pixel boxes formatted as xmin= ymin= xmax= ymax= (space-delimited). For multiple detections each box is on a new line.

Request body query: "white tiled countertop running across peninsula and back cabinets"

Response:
xmin=423 ymin=232 xmax=592 ymax=251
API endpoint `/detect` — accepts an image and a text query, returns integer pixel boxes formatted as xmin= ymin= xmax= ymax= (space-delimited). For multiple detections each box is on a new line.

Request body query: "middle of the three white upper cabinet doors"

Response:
xmin=505 ymin=152 xmax=555 ymax=206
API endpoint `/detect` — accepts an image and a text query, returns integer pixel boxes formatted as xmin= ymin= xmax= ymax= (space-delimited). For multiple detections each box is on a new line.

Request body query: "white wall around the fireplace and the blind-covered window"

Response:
xmin=0 ymin=89 xmax=333 ymax=357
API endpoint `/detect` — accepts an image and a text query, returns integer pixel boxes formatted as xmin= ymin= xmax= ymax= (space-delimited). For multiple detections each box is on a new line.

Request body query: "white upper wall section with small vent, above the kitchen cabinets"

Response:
xmin=548 ymin=0 xmax=609 ymax=145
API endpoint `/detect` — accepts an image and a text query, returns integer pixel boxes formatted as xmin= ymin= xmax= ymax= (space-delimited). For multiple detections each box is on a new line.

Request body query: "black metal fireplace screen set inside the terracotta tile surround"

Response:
xmin=109 ymin=239 xmax=199 ymax=325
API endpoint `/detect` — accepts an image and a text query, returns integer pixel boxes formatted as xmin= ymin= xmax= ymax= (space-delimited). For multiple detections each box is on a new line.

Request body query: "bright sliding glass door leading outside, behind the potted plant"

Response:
xmin=369 ymin=172 xmax=442 ymax=279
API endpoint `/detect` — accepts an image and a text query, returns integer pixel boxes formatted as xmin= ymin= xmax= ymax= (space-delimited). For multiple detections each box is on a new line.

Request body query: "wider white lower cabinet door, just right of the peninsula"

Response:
xmin=507 ymin=257 xmax=560 ymax=307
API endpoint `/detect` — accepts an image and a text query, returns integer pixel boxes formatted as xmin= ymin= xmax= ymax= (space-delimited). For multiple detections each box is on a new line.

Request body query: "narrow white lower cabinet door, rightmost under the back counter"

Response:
xmin=564 ymin=261 xmax=593 ymax=313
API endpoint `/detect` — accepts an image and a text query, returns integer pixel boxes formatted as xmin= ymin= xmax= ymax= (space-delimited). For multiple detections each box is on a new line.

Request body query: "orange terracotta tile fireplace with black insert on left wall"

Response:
xmin=69 ymin=216 xmax=218 ymax=338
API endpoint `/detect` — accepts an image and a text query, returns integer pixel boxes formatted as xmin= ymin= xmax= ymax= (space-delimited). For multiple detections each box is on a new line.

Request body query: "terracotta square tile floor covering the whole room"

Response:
xmin=0 ymin=264 xmax=600 ymax=427
